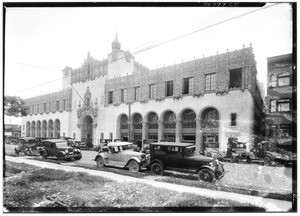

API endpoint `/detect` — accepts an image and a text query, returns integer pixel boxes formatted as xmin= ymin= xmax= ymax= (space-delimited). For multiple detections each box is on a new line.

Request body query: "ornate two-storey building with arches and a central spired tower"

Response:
xmin=22 ymin=36 xmax=263 ymax=153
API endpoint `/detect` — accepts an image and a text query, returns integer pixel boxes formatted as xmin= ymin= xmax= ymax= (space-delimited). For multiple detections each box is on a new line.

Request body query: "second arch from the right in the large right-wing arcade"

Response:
xmin=180 ymin=109 xmax=196 ymax=141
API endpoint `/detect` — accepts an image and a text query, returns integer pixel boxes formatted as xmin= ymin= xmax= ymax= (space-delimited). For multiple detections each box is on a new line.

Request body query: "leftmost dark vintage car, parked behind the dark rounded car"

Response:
xmin=14 ymin=137 xmax=38 ymax=155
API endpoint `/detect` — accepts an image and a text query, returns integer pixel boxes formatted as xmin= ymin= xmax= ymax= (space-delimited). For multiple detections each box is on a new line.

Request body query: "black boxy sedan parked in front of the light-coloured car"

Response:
xmin=148 ymin=142 xmax=225 ymax=182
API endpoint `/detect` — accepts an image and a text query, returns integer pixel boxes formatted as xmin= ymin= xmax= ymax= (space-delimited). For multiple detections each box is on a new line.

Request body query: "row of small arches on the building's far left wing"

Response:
xmin=26 ymin=119 xmax=60 ymax=138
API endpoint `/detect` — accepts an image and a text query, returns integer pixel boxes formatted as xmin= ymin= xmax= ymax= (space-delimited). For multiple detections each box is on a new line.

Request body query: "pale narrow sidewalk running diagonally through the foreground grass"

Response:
xmin=5 ymin=156 xmax=292 ymax=212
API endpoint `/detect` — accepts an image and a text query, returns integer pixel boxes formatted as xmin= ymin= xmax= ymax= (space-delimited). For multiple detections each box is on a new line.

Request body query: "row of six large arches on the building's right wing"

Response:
xmin=117 ymin=107 xmax=220 ymax=143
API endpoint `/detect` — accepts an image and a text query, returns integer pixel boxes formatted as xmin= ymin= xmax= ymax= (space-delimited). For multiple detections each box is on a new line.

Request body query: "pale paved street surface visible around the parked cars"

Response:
xmin=5 ymin=145 xmax=292 ymax=194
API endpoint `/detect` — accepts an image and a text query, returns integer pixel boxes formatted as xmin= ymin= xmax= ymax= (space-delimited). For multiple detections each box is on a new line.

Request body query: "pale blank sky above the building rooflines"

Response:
xmin=4 ymin=3 xmax=292 ymax=123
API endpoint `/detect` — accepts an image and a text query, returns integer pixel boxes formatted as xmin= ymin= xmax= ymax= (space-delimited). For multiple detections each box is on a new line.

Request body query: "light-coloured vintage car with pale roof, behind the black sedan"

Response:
xmin=94 ymin=142 xmax=147 ymax=172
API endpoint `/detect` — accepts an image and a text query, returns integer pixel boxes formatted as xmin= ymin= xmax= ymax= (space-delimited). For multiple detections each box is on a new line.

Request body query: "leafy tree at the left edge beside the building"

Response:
xmin=4 ymin=96 xmax=29 ymax=117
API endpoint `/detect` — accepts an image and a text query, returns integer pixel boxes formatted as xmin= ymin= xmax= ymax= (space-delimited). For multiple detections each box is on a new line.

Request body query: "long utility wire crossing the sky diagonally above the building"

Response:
xmin=6 ymin=3 xmax=280 ymax=94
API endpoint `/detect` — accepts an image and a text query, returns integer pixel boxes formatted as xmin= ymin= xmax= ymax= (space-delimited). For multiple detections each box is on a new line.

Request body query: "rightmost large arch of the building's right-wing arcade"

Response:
xmin=201 ymin=108 xmax=219 ymax=148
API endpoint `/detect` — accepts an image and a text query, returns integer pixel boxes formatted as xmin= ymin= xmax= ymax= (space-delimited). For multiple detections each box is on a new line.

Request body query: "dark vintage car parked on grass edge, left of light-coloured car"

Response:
xmin=38 ymin=139 xmax=82 ymax=160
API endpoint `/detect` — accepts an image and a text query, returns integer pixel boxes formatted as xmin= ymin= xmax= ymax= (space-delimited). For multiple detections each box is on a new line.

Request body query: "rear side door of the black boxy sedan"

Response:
xmin=166 ymin=146 xmax=183 ymax=169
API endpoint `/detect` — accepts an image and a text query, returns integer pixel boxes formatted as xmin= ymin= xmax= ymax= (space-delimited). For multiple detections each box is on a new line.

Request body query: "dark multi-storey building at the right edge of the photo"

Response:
xmin=266 ymin=54 xmax=297 ymax=151
